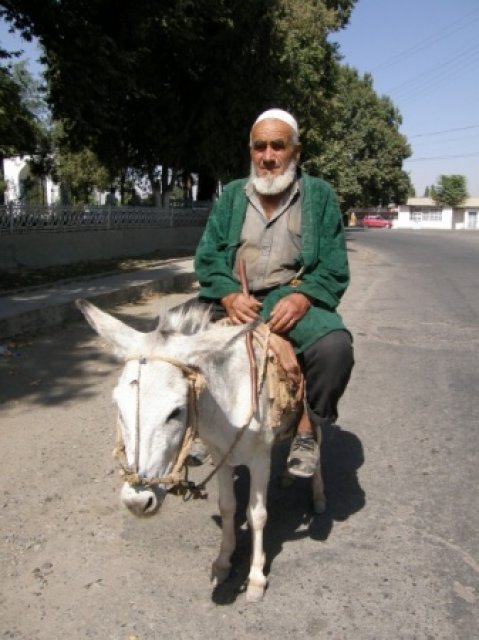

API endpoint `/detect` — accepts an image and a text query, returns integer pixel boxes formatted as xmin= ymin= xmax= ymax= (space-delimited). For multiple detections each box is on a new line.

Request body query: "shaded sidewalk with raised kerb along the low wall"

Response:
xmin=0 ymin=258 xmax=195 ymax=340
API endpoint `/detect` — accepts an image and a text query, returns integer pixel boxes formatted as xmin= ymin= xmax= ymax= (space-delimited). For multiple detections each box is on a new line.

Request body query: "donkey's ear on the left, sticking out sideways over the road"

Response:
xmin=75 ymin=300 xmax=158 ymax=358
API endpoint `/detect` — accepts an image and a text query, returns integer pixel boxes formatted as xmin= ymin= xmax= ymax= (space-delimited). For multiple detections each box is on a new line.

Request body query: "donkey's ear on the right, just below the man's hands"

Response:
xmin=188 ymin=320 xmax=262 ymax=367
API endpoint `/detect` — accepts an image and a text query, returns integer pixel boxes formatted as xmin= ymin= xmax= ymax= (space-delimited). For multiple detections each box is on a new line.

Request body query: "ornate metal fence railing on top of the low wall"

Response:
xmin=0 ymin=202 xmax=211 ymax=234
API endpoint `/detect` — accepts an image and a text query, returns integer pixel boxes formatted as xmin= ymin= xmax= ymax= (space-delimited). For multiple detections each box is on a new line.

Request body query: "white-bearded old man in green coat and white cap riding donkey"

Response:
xmin=195 ymin=109 xmax=353 ymax=477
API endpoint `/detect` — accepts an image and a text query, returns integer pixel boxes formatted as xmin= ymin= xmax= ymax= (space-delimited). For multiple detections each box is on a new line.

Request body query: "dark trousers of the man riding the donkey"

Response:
xmin=185 ymin=294 xmax=354 ymax=427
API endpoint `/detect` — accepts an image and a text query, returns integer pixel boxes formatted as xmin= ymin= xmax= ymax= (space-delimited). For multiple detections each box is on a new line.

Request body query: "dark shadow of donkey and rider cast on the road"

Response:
xmin=212 ymin=426 xmax=366 ymax=605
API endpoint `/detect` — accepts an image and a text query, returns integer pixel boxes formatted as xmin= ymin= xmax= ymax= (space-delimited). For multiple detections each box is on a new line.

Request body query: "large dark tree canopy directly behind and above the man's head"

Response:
xmin=0 ymin=0 xmax=354 ymax=196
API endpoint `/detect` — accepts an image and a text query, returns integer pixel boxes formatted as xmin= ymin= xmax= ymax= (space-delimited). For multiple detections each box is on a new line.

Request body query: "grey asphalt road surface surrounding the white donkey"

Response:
xmin=0 ymin=230 xmax=479 ymax=640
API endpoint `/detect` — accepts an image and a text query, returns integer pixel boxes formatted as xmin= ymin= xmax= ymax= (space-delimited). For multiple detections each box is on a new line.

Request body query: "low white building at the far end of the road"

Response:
xmin=394 ymin=198 xmax=479 ymax=234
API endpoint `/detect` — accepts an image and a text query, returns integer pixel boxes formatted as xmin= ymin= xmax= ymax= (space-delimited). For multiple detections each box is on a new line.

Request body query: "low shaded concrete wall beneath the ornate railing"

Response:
xmin=0 ymin=226 xmax=203 ymax=271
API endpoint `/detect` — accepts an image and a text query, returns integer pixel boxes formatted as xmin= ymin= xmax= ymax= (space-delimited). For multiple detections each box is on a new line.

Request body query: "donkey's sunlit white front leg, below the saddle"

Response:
xmin=246 ymin=452 xmax=270 ymax=602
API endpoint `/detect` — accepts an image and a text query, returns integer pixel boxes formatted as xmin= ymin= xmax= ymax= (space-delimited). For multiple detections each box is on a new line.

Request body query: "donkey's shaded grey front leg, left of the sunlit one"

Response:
xmin=211 ymin=465 xmax=236 ymax=585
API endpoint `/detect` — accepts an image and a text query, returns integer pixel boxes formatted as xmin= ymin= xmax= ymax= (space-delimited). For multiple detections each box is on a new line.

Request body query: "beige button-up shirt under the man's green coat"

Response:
xmin=235 ymin=180 xmax=301 ymax=292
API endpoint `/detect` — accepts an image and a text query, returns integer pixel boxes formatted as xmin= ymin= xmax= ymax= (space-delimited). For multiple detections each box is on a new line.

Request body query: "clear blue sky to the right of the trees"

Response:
xmin=330 ymin=0 xmax=479 ymax=197
